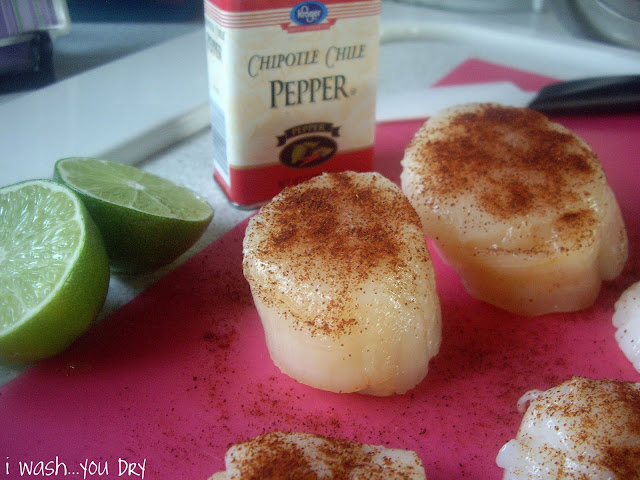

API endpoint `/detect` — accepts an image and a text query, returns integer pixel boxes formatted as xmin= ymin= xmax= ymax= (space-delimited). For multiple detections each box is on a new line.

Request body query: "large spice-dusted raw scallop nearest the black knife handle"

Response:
xmin=401 ymin=104 xmax=627 ymax=315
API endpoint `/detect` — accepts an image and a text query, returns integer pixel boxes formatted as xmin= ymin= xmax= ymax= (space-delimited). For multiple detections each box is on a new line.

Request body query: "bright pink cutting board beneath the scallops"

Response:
xmin=0 ymin=60 xmax=640 ymax=480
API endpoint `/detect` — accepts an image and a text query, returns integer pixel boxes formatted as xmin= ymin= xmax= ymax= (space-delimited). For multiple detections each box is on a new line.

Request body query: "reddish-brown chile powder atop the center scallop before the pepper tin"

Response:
xmin=244 ymin=172 xmax=429 ymax=335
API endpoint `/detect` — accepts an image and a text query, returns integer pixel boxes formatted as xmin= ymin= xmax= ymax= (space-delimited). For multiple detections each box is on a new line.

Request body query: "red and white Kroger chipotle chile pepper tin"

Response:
xmin=205 ymin=0 xmax=381 ymax=207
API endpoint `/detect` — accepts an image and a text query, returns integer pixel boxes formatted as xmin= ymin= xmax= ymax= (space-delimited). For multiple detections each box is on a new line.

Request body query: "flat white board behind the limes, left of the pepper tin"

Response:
xmin=0 ymin=30 xmax=208 ymax=184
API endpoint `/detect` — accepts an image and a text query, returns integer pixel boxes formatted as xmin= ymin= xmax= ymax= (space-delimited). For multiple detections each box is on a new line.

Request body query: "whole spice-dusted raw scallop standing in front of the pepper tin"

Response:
xmin=243 ymin=172 xmax=441 ymax=395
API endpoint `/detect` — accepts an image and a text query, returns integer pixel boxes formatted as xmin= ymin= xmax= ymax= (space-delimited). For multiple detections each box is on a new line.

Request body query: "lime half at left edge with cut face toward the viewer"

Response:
xmin=0 ymin=180 xmax=109 ymax=363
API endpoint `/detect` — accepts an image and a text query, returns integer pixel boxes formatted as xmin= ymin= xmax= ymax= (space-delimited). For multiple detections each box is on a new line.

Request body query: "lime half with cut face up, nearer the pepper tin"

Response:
xmin=54 ymin=157 xmax=213 ymax=273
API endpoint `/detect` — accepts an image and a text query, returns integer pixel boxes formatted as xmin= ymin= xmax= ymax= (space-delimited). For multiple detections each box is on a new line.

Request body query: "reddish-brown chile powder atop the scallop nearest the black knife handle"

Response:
xmin=409 ymin=104 xmax=604 ymax=219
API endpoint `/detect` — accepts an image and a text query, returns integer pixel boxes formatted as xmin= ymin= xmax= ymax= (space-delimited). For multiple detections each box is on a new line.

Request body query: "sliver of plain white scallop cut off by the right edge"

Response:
xmin=613 ymin=282 xmax=640 ymax=372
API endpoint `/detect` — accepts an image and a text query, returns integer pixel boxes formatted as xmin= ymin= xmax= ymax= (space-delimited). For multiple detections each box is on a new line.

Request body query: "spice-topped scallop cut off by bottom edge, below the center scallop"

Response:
xmin=209 ymin=432 xmax=427 ymax=480
